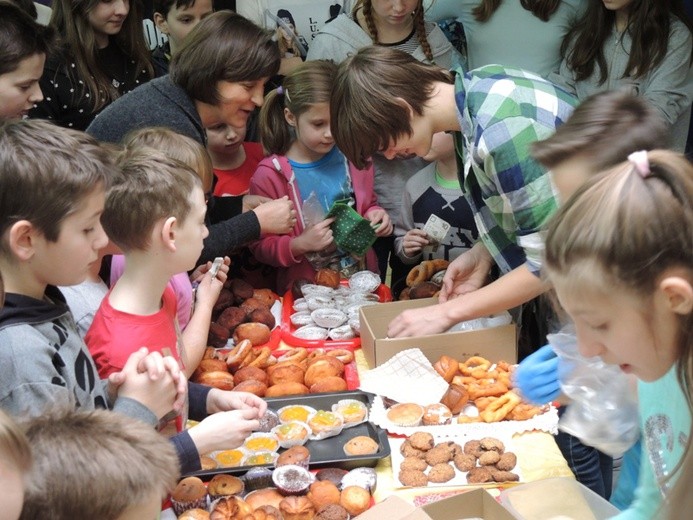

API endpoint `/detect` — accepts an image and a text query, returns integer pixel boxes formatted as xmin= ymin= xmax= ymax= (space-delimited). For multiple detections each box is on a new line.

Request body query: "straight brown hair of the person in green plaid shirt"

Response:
xmin=330 ymin=45 xmax=453 ymax=168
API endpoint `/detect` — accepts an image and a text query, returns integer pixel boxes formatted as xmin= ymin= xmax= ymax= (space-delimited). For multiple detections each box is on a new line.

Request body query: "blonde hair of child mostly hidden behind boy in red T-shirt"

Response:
xmin=123 ymin=126 xmax=214 ymax=193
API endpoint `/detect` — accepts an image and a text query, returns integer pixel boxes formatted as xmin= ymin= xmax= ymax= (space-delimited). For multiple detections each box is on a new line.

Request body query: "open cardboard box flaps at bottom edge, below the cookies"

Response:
xmin=356 ymin=488 xmax=515 ymax=520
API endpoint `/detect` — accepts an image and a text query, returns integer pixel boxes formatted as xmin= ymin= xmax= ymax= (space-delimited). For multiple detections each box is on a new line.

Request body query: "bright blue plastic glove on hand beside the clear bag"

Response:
xmin=514 ymin=345 xmax=561 ymax=404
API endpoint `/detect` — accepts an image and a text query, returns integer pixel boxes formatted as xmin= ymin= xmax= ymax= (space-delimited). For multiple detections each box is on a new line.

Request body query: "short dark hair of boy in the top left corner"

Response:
xmin=0 ymin=1 xmax=55 ymax=75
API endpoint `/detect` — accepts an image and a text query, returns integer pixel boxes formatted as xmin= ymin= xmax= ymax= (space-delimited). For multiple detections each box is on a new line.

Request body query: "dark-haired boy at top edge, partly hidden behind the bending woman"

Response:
xmin=152 ymin=0 xmax=213 ymax=76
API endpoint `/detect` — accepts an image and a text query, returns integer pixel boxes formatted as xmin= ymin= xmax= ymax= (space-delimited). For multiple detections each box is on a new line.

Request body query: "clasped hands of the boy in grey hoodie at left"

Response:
xmin=109 ymin=347 xmax=181 ymax=419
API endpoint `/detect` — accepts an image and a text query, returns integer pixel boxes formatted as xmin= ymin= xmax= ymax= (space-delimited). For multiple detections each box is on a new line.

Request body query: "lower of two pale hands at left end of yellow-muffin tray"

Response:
xmin=188 ymin=408 xmax=260 ymax=454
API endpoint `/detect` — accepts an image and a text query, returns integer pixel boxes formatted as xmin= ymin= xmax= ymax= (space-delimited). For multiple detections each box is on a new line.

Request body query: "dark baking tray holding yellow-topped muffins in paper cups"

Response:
xmin=184 ymin=390 xmax=390 ymax=480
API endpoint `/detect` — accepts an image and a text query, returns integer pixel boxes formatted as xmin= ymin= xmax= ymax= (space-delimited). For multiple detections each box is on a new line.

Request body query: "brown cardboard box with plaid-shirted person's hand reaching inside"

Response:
xmin=360 ymin=298 xmax=517 ymax=368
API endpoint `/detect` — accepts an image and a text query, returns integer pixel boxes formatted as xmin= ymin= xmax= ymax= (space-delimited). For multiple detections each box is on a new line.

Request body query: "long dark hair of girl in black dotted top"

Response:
xmin=50 ymin=0 xmax=154 ymax=112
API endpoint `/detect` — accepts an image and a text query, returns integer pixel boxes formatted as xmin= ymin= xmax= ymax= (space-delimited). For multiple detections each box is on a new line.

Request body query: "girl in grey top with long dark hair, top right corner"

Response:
xmin=549 ymin=0 xmax=693 ymax=152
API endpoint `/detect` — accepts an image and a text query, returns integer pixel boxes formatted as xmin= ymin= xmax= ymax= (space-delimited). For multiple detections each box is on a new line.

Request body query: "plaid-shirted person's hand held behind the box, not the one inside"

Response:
xmin=440 ymin=242 xmax=493 ymax=302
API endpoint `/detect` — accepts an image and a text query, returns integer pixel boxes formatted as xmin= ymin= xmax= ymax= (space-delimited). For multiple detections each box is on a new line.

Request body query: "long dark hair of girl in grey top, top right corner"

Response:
xmin=561 ymin=0 xmax=693 ymax=85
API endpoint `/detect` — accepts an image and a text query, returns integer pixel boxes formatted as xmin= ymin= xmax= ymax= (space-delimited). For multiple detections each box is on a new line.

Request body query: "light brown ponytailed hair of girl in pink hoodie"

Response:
xmin=260 ymin=60 xmax=337 ymax=155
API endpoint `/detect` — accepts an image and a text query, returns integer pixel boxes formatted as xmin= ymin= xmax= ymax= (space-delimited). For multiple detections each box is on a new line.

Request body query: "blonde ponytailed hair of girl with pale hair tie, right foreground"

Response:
xmin=544 ymin=150 xmax=693 ymax=511
